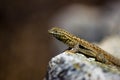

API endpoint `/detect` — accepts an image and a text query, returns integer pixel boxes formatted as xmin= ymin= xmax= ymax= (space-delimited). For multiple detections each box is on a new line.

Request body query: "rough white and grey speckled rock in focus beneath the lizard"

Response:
xmin=45 ymin=51 xmax=120 ymax=80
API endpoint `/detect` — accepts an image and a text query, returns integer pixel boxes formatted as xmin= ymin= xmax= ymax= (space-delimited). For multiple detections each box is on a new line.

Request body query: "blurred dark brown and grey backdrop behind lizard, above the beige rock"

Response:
xmin=0 ymin=0 xmax=120 ymax=80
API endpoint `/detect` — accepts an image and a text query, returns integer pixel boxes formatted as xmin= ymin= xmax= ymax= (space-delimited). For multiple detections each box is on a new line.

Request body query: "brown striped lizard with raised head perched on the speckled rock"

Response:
xmin=48 ymin=27 xmax=120 ymax=67
